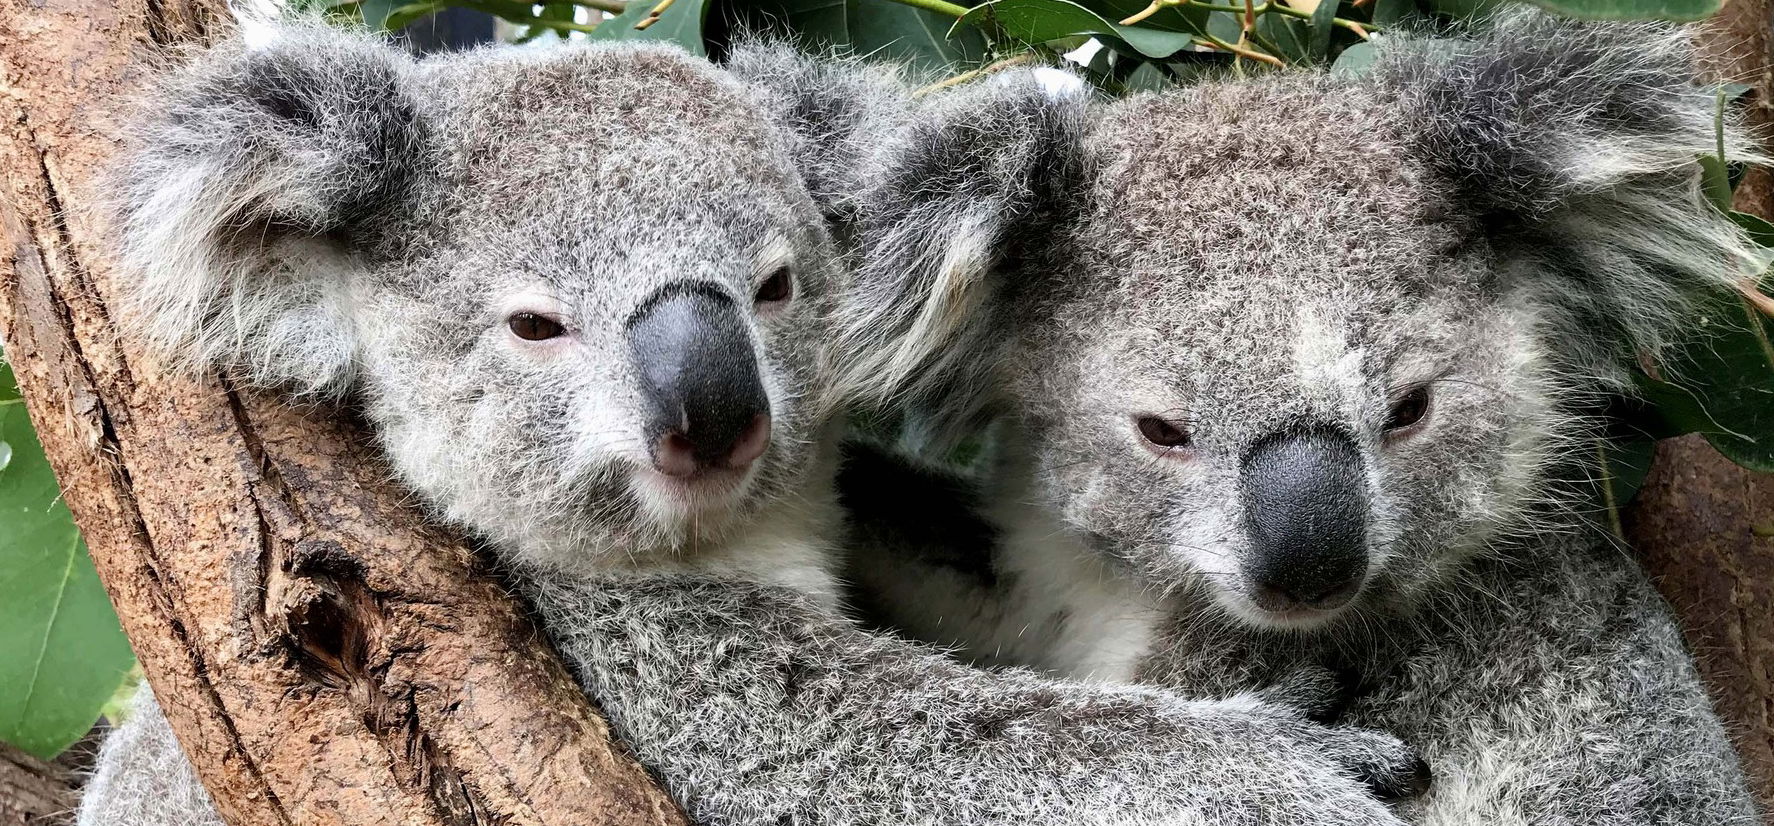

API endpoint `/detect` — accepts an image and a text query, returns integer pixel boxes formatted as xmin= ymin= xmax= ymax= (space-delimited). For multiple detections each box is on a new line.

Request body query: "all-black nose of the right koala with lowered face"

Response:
xmin=1240 ymin=431 xmax=1368 ymax=610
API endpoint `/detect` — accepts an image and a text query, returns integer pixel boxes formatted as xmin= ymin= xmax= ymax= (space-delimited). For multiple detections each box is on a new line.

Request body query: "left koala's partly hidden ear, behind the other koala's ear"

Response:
xmin=722 ymin=37 xmax=910 ymax=224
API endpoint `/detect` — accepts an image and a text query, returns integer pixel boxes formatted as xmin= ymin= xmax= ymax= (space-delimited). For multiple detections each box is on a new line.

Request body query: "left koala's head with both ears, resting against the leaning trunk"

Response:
xmin=117 ymin=20 xmax=896 ymax=567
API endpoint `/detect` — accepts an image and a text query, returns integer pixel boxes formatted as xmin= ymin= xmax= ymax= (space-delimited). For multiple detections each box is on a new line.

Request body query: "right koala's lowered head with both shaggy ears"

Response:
xmin=855 ymin=14 xmax=1758 ymax=627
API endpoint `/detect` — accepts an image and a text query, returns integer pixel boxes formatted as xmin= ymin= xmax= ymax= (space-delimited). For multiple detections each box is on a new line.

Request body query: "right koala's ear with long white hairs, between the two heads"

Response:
xmin=839 ymin=69 xmax=1093 ymax=432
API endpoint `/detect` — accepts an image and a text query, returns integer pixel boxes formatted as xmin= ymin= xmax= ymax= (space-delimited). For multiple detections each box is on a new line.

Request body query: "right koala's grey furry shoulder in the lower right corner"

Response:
xmin=1357 ymin=546 xmax=1762 ymax=826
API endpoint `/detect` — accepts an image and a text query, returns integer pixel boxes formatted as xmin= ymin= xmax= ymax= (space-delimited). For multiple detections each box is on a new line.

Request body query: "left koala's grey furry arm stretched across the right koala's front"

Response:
xmin=525 ymin=576 xmax=1421 ymax=826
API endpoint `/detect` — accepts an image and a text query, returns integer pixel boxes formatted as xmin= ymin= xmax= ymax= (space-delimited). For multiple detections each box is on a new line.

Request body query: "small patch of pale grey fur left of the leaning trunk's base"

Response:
xmin=75 ymin=684 xmax=224 ymax=826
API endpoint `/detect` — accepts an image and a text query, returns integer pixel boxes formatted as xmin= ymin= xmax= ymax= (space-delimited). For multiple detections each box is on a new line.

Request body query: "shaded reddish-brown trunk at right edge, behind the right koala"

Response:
xmin=1627 ymin=0 xmax=1774 ymax=811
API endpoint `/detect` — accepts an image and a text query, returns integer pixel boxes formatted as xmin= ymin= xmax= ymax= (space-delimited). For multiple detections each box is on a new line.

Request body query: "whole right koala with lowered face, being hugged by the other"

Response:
xmin=844 ymin=14 xmax=1763 ymax=826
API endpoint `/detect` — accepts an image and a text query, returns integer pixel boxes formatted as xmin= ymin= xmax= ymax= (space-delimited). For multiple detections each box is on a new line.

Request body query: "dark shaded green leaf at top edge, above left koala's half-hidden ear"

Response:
xmin=736 ymin=0 xmax=988 ymax=74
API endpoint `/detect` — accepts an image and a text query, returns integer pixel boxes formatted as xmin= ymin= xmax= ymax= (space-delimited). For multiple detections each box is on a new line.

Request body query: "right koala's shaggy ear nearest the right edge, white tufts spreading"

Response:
xmin=1375 ymin=11 xmax=1765 ymax=378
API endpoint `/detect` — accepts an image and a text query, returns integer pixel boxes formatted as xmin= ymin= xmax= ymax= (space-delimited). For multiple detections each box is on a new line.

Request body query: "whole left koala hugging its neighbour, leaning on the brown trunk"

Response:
xmin=82 ymin=19 xmax=1423 ymax=826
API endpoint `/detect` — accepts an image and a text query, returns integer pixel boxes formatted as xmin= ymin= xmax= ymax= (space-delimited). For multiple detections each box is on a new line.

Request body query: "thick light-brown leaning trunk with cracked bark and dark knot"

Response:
xmin=0 ymin=0 xmax=683 ymax=826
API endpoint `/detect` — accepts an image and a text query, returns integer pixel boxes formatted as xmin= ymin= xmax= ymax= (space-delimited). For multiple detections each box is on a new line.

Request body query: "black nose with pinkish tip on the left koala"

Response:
xmin=628 ymin=282 xmax=770 ymax=477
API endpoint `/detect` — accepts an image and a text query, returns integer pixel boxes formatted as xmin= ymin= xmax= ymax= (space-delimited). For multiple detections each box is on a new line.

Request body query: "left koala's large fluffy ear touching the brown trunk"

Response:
xmin=110 ymin=23 xmax=419 ymax=394
